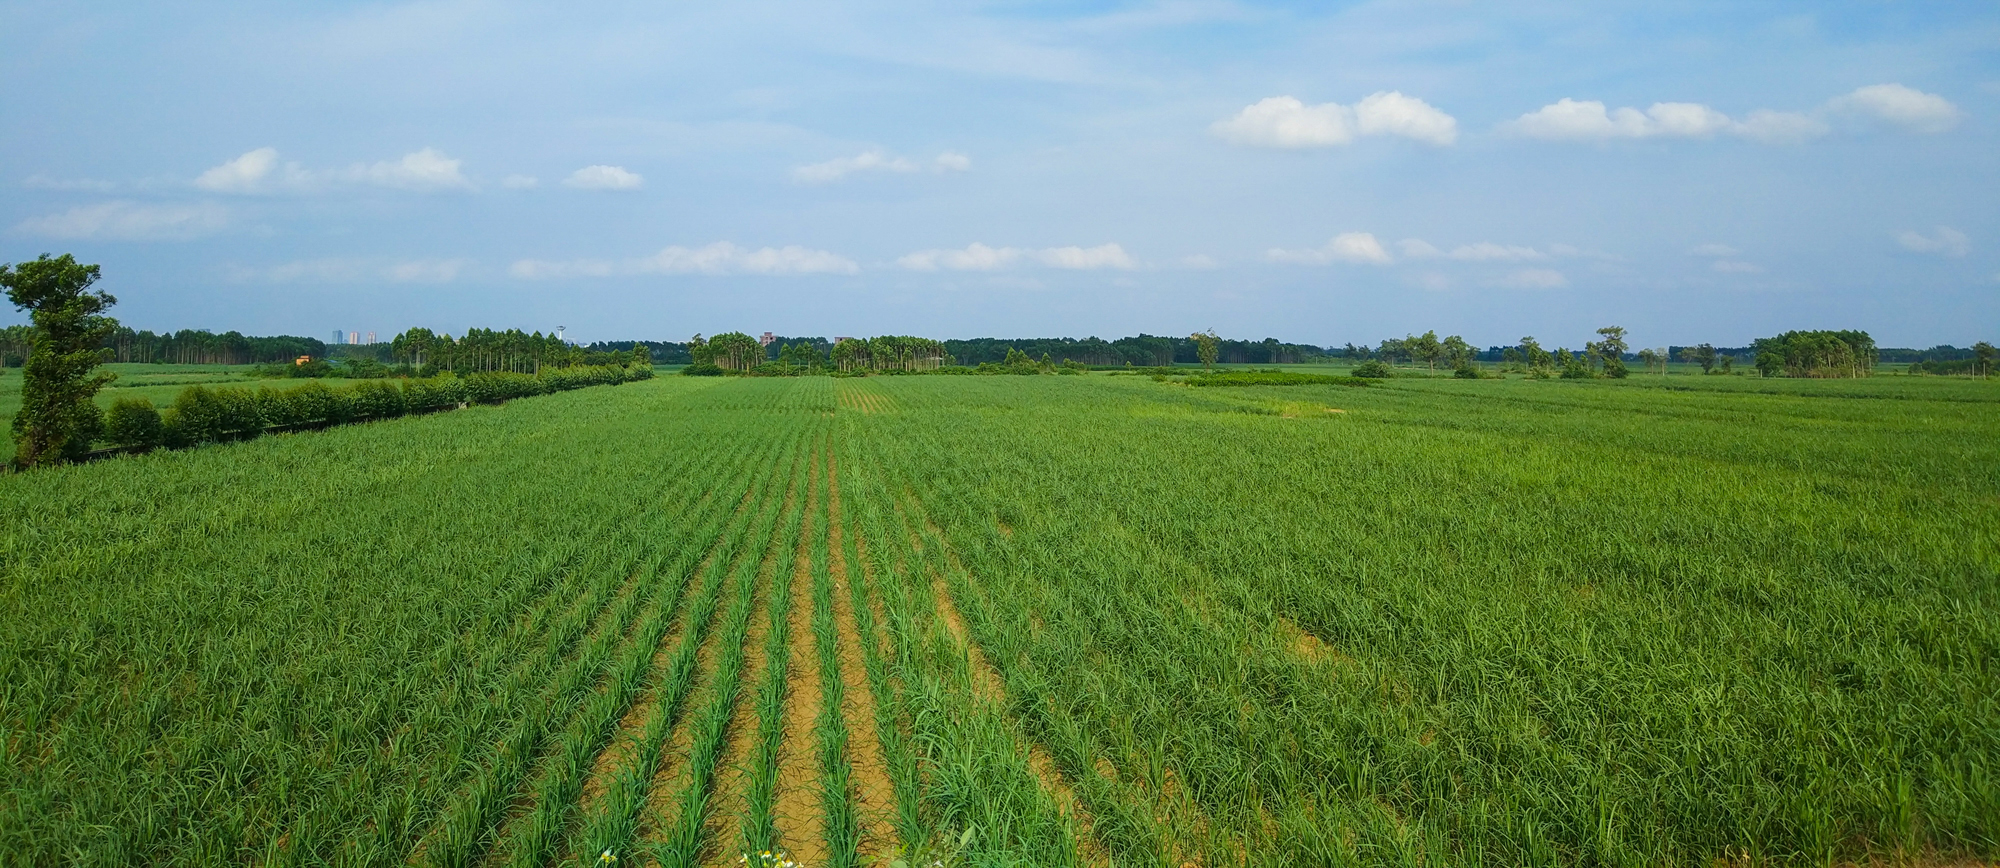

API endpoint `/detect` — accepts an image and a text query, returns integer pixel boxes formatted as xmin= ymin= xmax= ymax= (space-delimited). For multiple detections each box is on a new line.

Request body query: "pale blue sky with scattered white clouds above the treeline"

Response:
xmin=0 ymin=0 xmax=2000 ymax=346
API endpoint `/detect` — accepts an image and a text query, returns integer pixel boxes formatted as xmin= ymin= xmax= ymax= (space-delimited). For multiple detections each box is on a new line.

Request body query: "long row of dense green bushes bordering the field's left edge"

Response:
xmin=102 ymin=366 xmax=652 ymax=450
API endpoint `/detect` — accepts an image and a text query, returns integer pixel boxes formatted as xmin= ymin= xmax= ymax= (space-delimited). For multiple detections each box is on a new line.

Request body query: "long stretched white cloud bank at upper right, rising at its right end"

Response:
xmin=1500 ymin=84 xmax=1960 ymax=144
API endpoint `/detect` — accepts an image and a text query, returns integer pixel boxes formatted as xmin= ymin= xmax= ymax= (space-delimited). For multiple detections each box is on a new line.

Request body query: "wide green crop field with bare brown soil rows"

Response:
xmin=0 ymin=368 xmax=2000 ymax=868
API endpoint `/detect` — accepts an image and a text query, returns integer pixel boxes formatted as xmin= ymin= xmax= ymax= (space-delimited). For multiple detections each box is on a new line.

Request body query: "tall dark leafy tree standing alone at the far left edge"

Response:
xmin=0 ymin=254 xmax=118 ymax=466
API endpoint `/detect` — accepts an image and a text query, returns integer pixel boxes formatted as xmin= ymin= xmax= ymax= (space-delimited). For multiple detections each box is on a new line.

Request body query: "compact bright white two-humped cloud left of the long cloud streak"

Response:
xmin=1210 ymin=90 xmax=1458 ymax=148
